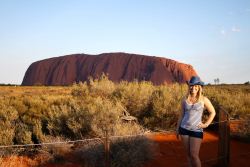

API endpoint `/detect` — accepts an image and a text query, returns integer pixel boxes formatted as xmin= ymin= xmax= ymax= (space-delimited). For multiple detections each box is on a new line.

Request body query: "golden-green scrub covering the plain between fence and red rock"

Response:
xmin=0 ymin=76 xmax=250 ymax=166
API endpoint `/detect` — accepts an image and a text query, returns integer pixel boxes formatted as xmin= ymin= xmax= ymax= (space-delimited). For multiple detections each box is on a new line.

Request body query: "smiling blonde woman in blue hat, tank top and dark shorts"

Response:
xmin=176 ymin=76 xmax=215 ymax=167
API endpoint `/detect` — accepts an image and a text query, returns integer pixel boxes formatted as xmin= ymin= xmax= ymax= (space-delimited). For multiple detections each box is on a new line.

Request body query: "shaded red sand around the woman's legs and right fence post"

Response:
xmin=144 ymin=132 xmax=250 ymax=167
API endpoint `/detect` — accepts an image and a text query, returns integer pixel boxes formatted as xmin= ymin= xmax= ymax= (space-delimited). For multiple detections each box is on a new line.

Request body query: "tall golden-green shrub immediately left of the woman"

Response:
xmin=143 ymin=84 xmax=184 ymax=130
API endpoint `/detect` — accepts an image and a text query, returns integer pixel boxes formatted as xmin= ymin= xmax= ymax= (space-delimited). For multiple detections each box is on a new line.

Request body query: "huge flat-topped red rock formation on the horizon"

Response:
xmin=22 ymin=53 xmax=197 ymax=85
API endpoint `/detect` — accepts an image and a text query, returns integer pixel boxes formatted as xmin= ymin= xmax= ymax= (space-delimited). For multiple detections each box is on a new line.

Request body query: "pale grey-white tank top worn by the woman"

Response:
xmin=181 ymin=100 xmax=204 ymax=132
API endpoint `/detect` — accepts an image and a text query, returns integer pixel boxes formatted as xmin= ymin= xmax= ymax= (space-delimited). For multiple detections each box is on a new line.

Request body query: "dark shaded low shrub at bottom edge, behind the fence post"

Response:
xmin=73 ymin=137 xmax=155 ymax=167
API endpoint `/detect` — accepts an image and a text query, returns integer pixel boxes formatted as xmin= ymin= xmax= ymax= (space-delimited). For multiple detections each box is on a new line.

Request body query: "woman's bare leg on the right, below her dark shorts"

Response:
xmin=189 ymin=137 xmax=202 ymax=167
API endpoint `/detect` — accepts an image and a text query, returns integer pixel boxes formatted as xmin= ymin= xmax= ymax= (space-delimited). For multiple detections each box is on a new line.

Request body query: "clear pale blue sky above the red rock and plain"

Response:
xmin=0 ymin=0 xmax=250 ymax=84
